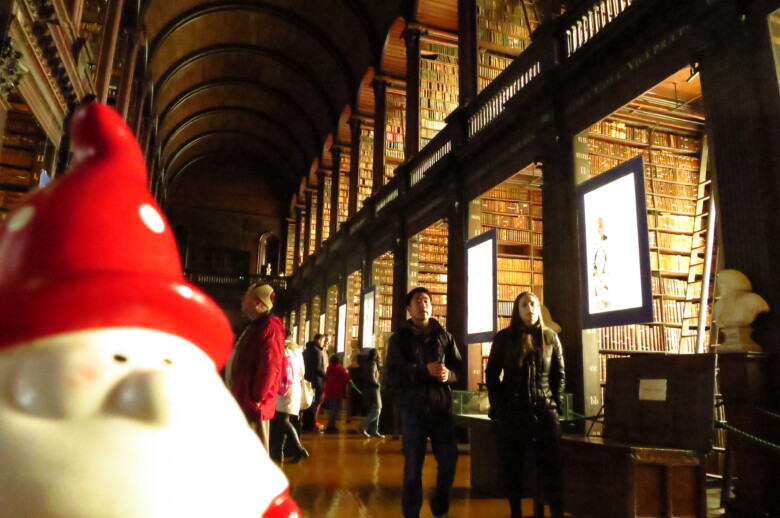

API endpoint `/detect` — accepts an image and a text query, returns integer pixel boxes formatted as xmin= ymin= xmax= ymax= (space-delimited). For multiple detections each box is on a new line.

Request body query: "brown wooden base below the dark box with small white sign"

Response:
xmin=561 ymin=436 xmax=707 ymax=518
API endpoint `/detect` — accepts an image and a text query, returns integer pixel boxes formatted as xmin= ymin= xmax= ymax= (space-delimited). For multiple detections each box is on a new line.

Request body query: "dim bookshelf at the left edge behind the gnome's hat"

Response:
xmin=0 ymin=94 xmax=47 ymax=221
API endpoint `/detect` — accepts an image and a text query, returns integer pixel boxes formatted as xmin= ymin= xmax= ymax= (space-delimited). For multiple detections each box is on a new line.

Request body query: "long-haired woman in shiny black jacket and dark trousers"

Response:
xmin=485 ymin=291 xmax=566 ymax=518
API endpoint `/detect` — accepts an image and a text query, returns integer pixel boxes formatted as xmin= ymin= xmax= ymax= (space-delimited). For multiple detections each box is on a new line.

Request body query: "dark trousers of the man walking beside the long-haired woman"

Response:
xmin=401 ymin=412 xmax=458 ymax=518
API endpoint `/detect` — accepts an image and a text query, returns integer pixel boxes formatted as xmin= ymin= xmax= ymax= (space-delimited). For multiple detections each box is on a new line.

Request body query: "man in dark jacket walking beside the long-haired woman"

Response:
xmin=386 ymin=287 xmax=463 ymax=518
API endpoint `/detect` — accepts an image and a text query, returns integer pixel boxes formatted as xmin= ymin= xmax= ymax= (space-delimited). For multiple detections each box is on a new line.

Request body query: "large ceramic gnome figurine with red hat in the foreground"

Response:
xmin=0 ymin=103 xmax=299 ymax=518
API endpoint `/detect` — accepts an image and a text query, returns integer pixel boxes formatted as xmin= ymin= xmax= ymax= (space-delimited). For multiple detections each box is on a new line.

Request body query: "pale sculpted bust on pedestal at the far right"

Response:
xmin=712 ymin=270 xmax=769 ymax=353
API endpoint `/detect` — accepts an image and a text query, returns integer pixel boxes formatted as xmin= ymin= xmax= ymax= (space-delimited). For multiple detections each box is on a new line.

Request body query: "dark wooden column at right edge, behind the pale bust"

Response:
xmin=700 ymin=5 xmax=780 ymax=354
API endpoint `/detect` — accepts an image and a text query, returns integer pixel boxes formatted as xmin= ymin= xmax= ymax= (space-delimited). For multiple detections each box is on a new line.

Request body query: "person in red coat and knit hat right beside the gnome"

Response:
xmin=225 ymin=284 xmax=285 ymax=451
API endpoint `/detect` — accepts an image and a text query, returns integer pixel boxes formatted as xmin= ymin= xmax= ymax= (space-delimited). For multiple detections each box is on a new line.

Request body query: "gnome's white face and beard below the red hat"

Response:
xmin=0 ymin=328 xmax=287 ymax=518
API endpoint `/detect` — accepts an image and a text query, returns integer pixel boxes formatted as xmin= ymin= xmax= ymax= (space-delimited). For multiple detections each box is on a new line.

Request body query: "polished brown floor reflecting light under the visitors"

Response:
xmin=282 ymin=421 xmax=722 ymax=518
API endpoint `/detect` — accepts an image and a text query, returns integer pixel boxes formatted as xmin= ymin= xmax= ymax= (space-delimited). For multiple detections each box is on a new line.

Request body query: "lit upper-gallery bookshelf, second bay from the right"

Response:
xmin=420 ymin=39 xmax=459 ymax=149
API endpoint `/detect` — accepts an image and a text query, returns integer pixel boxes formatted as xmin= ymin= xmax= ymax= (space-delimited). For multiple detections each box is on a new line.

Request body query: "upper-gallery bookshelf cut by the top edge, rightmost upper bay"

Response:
xmin=477 ymin=0 xmax=539 ymax=92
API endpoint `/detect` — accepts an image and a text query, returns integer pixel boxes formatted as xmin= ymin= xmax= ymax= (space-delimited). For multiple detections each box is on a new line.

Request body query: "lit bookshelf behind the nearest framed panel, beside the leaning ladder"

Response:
xmin=588 ymin=102 xmax=710 ymax=383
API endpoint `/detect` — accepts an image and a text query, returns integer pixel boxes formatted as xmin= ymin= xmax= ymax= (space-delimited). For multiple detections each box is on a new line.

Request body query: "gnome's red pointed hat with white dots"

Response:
xmin=0 ymin=103 xmax=233 ymax=368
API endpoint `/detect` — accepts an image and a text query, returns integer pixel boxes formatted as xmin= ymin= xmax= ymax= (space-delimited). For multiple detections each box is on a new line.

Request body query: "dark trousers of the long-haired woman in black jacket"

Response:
xmin=499 ymin=428 xmax=563 ymax=518
